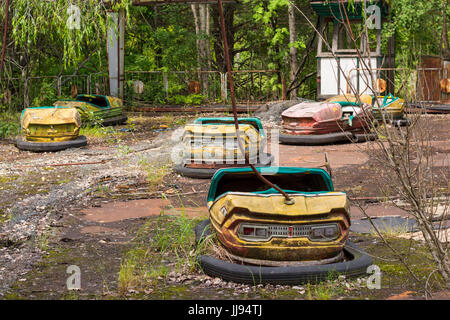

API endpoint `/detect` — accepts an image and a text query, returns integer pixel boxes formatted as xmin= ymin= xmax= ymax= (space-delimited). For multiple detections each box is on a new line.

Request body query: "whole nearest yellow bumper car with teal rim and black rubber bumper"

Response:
xmin=195 ymin=167 xmax=372 ymax=284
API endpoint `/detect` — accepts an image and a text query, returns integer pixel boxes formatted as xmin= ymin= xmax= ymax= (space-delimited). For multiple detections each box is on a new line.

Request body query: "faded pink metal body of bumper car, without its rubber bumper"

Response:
xmin=281 ymin=101 xmax=371 ymax=135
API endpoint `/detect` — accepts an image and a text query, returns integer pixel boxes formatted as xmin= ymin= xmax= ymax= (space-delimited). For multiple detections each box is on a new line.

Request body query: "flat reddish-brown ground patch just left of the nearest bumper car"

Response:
xmin=81 ymin=199 xmax=208 ymax=223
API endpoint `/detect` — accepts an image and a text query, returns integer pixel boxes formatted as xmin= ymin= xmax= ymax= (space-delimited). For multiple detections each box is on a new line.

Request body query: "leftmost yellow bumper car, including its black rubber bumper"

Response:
xmin=16 ymin=107 xmax=87 ymax=152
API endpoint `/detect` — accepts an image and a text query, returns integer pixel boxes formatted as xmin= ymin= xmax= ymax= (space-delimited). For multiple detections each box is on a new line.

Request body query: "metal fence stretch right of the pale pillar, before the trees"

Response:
xmin=124 ymin=70 xmax=284 ymax=106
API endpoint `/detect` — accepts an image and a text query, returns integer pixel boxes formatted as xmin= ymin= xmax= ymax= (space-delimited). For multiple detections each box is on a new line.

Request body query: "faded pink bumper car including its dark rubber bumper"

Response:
xmin=280 ymin=96 xmax=377 ymax=145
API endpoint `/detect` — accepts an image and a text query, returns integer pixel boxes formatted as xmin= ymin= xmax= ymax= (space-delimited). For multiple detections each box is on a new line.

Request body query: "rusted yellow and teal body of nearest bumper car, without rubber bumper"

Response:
xmin=208 ymin=167 xmax=350 ymax=266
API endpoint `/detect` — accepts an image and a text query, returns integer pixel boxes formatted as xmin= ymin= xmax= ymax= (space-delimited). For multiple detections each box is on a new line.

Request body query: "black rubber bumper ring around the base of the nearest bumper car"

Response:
xmin=195 ymin=220 xmax=373 ymax=285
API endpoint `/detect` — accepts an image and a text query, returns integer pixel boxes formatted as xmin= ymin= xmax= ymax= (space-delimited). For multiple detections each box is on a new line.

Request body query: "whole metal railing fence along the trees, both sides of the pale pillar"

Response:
xmin=0 ymin=70 xmax=285 ymax=111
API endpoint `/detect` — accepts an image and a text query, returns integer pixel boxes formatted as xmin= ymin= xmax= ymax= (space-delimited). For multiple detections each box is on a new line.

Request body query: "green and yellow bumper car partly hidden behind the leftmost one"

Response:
xmin=53 ymin=94 xmax=127 ymax=126
